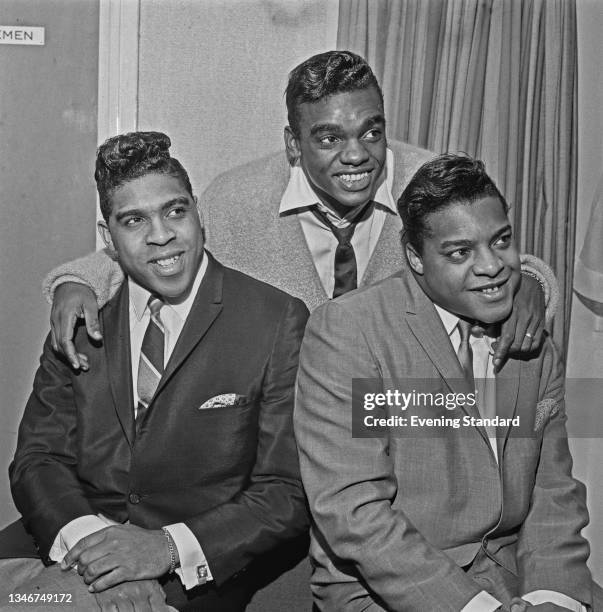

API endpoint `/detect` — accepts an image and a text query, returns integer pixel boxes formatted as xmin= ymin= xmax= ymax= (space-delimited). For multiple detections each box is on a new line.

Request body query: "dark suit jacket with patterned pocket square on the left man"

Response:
xmin=10 ymin=256 xmax=307 ymax=608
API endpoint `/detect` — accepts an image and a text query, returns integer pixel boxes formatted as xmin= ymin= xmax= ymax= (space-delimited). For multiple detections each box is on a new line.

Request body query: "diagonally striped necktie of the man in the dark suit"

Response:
xmin=136 ymin=296 xmax=165 ymax=433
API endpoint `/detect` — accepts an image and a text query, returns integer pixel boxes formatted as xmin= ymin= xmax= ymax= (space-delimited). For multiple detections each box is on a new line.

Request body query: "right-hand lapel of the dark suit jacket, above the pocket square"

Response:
xmin=155 ymin=252 xmax=224 ymax=397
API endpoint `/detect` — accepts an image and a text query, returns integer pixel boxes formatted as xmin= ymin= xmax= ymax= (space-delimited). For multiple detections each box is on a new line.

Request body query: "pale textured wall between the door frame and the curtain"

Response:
xmin=138 ymin=0 xmax=338 ymax=193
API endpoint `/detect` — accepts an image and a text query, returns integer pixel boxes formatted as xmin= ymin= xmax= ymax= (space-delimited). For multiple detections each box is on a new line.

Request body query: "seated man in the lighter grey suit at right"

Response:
xmin=294 ymin=155 xmax=596 ymax=612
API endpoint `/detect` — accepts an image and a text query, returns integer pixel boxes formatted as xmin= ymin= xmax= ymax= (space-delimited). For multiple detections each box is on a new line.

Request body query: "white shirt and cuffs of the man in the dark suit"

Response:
xmin=50 ymin=254 xmax=213 ymax=589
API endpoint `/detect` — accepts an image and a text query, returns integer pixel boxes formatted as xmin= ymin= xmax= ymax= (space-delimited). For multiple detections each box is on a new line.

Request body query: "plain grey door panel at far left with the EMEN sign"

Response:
xmin=0 ymin=0 xmax=98 ymax=525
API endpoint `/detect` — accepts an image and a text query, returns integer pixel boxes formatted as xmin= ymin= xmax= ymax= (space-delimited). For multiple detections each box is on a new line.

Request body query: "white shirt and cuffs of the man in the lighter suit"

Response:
xmin=434 ymin=304 xmax=586 ymax=612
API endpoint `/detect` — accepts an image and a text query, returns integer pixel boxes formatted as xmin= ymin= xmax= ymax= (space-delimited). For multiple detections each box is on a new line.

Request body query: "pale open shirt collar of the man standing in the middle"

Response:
xmin=279 ymin=149 xmax=398 ymax=214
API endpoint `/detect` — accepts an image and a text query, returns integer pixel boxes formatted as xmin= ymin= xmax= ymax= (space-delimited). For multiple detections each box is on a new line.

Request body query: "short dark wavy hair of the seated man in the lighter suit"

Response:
xmin=398 ymin=153 xmax=509 ymax=253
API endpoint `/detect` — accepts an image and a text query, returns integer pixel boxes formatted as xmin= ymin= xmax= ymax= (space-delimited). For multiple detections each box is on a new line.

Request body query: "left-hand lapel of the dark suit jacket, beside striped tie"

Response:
xmin=101 ymin=282 xmax=134 ymax=446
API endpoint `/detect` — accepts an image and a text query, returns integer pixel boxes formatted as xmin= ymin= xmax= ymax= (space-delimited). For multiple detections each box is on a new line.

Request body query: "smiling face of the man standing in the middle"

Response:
xmin=285 ymin=87 xmax=387 ymax=215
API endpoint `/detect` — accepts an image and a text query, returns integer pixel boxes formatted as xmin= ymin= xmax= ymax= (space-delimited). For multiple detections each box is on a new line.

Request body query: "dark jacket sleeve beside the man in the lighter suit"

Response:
xmin=185 ymin=298 xmax=309 ymax=585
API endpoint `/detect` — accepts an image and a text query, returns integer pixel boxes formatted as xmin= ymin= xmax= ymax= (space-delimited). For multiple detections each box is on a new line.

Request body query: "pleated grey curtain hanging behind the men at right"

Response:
xmin=337 ymin=0 xmax=577 ymax=348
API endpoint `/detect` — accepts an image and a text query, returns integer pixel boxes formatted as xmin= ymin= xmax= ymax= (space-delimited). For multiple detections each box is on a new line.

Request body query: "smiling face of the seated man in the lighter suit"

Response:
xmin=406 ymin=196 xmax=520 ymax=323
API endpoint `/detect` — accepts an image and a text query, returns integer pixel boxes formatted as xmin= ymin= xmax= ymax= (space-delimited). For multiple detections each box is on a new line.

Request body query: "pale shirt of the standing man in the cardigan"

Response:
xmin=279 ymin=149 xmax=398 ymax=296
